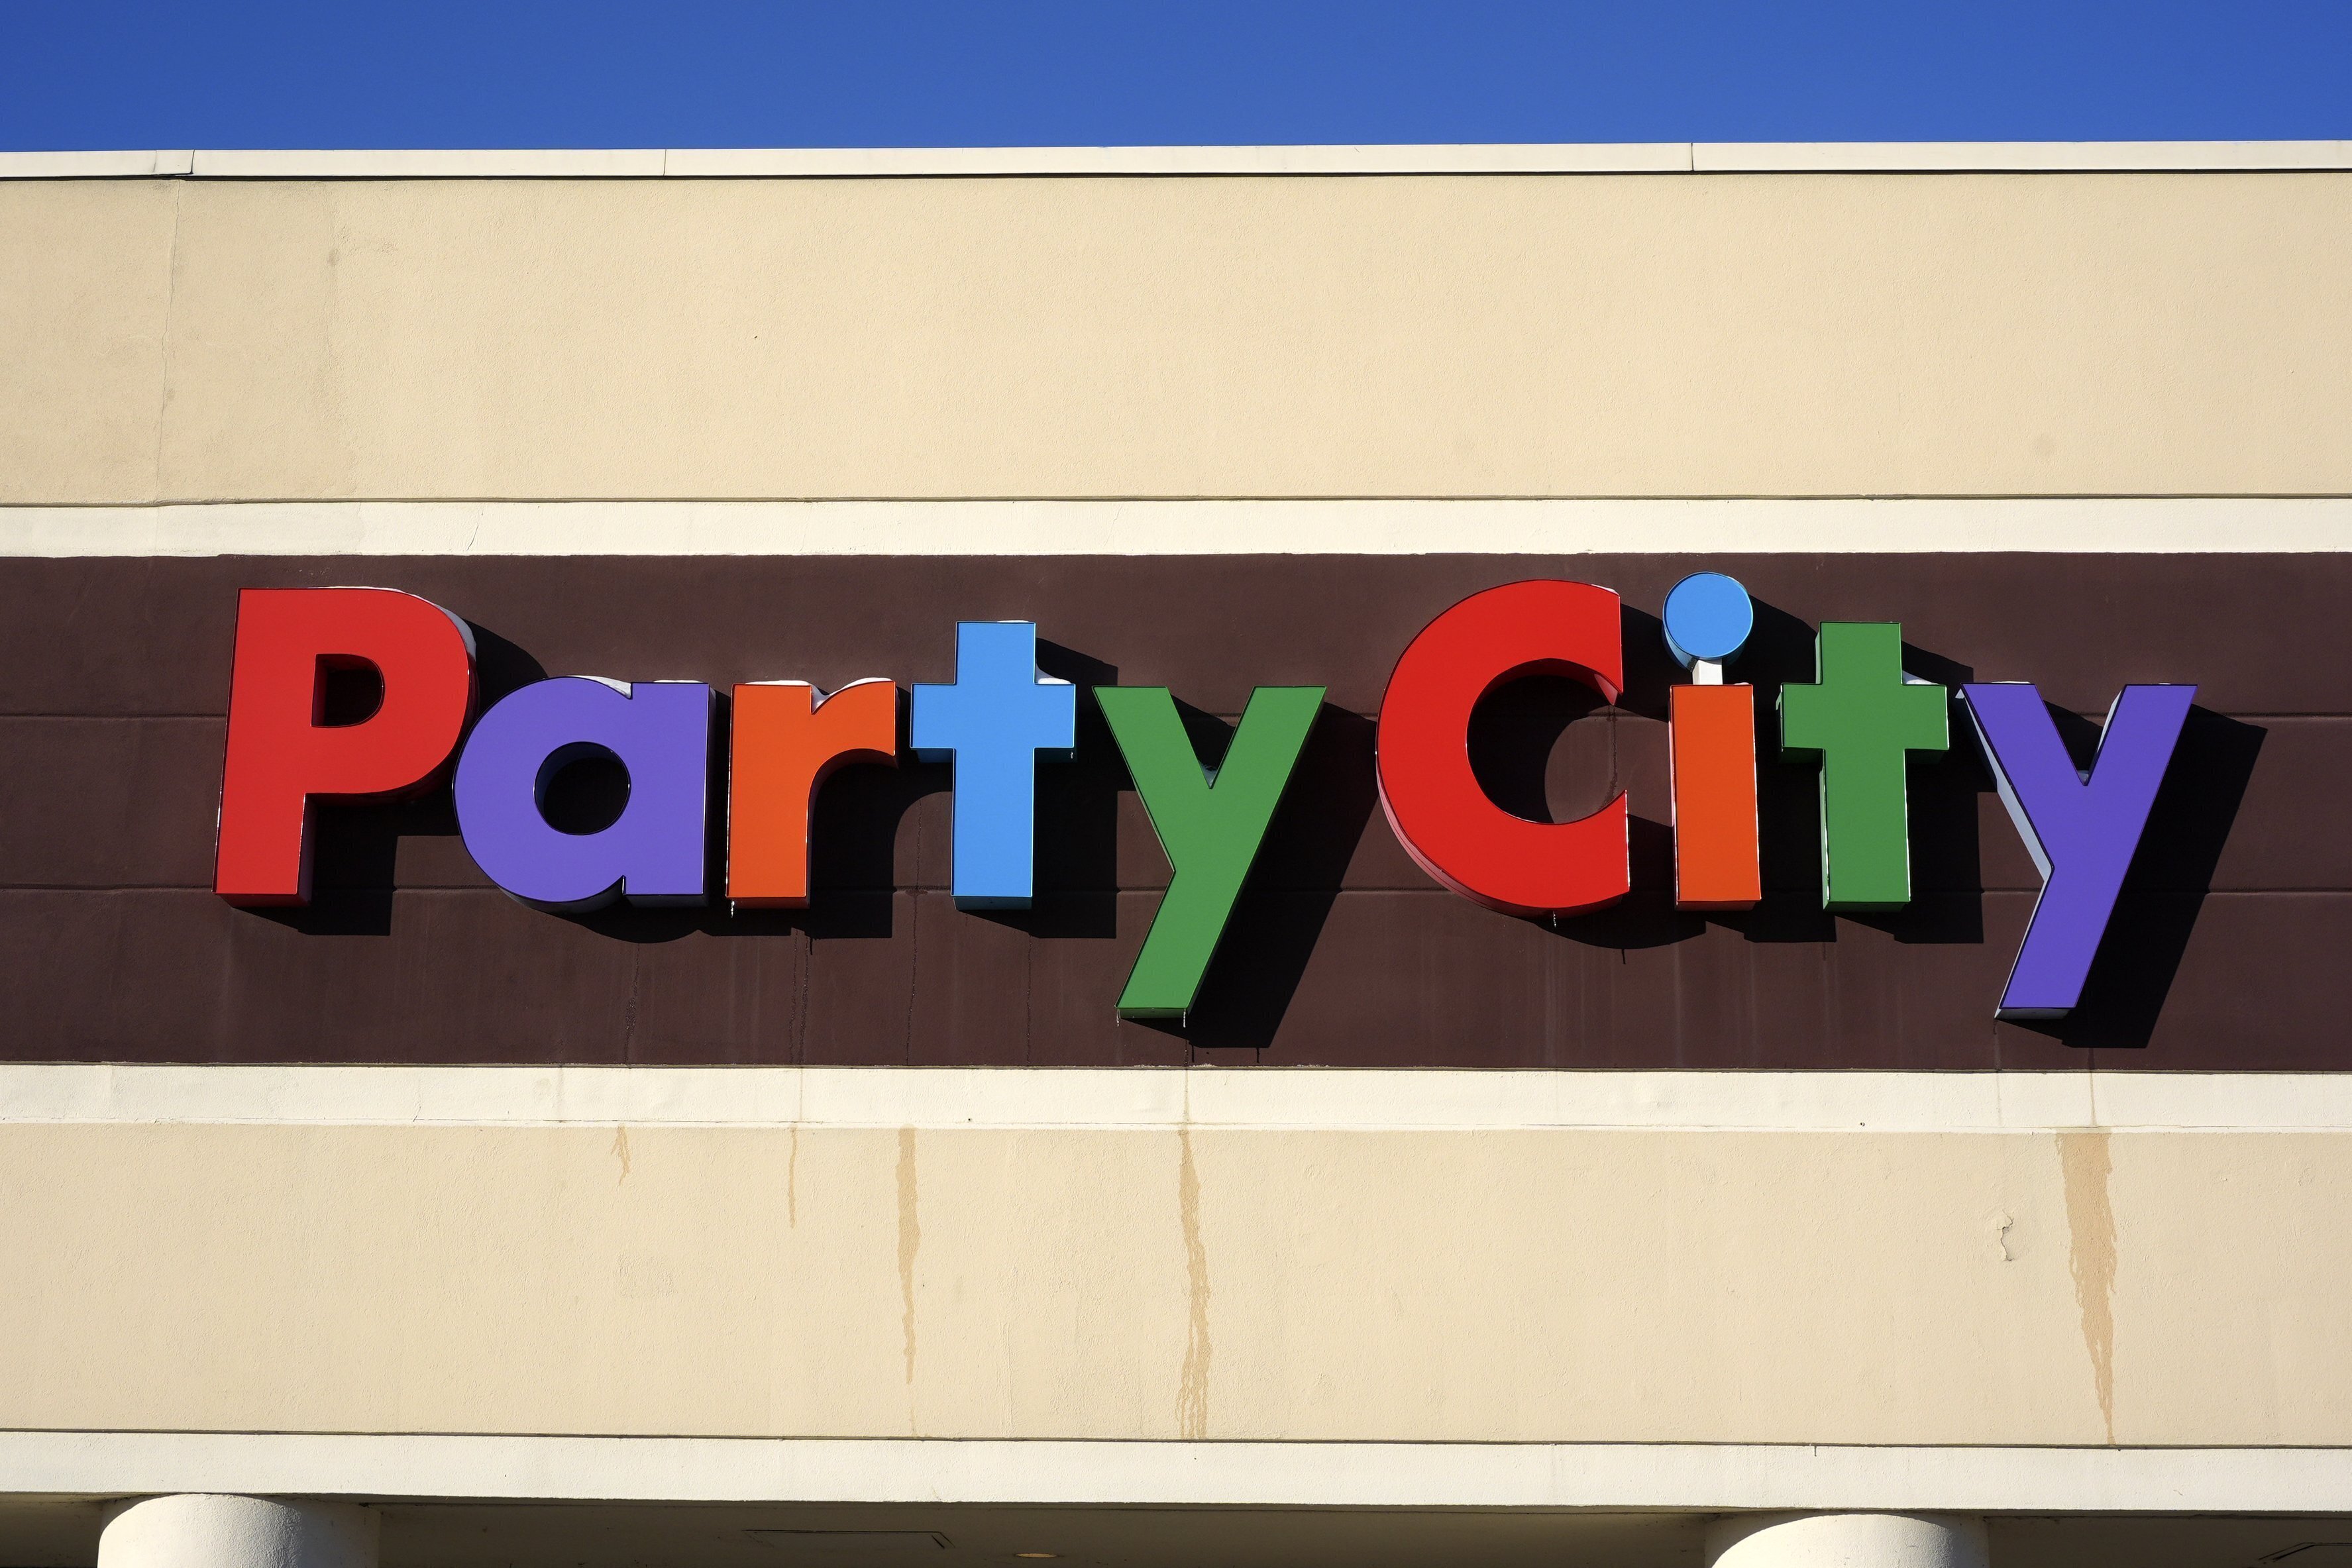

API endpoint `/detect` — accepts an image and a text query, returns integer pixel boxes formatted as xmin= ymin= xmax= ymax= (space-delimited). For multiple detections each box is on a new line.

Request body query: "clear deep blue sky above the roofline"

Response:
xmin=0 ymin=0 xmax=2352 ymax=148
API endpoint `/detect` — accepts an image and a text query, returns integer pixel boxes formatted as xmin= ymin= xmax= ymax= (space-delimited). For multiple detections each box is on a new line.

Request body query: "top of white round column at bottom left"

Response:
xmin=99 ymin=1492 xmax=376 ymax=1568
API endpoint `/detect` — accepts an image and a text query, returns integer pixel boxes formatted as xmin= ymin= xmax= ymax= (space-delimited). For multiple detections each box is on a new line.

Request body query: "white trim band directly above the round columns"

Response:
xmin=0 ymin=1432 xmax=2352 ymax=1514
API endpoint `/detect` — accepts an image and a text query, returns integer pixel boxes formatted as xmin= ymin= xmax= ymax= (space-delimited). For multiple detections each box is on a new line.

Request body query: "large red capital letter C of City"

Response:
xmin=1378 ymin=581 xmax=1632 ymax=914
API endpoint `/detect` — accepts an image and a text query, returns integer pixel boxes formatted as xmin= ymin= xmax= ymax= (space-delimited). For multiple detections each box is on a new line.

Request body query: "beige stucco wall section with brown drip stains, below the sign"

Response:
xmin=0 ymin=1126 xmax=2352 ymax=1445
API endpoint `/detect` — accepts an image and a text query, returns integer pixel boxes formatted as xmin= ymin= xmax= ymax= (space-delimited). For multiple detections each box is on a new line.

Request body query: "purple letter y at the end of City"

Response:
xmin=1962 ymin=682 xmax=2197 ymax=1018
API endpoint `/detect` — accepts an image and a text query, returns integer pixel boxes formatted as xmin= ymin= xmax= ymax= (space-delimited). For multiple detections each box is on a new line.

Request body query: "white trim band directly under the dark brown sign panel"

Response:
xmin=0 ymin=1063 xmax=2352 ymax=1133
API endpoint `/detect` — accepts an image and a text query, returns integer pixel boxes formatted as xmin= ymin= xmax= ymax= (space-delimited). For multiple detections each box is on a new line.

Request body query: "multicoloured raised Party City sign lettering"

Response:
xmin=214 ymin=574 xmax=2197 ymax=1018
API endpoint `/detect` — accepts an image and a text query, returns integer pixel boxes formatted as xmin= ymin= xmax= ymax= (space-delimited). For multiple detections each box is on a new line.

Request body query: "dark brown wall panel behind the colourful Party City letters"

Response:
xmin=0 ymin=554 xmax=2324 ymax=1070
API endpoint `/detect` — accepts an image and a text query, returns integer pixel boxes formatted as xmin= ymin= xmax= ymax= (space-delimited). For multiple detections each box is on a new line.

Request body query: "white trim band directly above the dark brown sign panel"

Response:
xmin=0 ymin=496 xmax=2352 ymax=557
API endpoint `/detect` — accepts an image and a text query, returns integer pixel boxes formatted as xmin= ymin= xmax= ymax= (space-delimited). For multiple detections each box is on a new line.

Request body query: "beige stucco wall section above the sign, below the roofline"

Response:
xmin=0 ymin=172 xmax=2352 ymax=503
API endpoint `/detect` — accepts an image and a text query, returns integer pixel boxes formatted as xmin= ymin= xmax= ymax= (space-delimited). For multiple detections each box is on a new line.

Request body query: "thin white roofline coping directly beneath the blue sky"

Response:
xmin=0 ymin=141 xmax=2352 ymax=179
